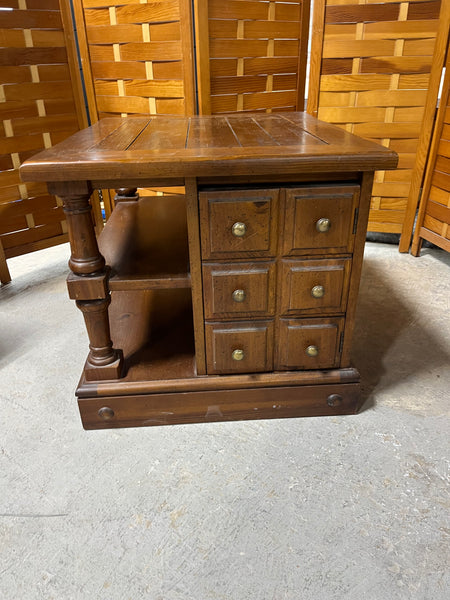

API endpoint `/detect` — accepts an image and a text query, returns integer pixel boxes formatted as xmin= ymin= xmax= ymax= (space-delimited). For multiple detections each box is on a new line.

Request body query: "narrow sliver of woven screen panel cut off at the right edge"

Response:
xmin=412 ymin=45 xmax=450 ymax=255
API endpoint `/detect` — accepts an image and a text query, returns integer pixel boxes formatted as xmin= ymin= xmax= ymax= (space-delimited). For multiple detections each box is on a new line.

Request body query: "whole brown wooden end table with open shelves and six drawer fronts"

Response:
xmin=22 ymin=113 xmax=396 ymax=428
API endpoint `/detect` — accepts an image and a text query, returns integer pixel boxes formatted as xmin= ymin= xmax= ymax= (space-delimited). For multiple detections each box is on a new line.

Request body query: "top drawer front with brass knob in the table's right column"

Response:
xmin=283 ymin=185 xmax=359 ymax=255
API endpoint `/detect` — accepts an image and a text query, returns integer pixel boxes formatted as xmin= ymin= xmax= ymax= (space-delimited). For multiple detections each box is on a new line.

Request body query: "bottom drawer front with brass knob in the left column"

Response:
xmin=206 ymin=321 xmax=273 ymax=374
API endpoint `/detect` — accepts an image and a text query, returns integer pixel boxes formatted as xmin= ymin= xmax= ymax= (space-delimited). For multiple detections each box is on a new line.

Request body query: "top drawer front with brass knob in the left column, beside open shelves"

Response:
xmin=199 ymin=190 xmax=279 ymax=259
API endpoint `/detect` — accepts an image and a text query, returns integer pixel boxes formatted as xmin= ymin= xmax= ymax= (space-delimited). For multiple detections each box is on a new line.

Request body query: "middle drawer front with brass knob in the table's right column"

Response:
xmin=280 ymin=258 xmax=351 ymax=315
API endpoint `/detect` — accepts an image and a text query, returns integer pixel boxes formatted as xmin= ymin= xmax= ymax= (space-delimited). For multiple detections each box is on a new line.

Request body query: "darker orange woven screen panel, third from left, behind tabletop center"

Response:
xmin=196 ymin=0 xmax=310 ymax=114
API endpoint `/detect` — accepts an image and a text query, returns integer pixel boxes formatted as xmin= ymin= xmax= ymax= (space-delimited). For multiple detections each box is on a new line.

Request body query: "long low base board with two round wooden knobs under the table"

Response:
xmin=78 ymin=383 xmax=360 ymax=429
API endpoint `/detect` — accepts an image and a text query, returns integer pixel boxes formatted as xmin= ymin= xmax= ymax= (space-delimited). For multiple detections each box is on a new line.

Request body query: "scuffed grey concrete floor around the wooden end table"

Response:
xmin=0 ymin=243 xmax=450 ymax=600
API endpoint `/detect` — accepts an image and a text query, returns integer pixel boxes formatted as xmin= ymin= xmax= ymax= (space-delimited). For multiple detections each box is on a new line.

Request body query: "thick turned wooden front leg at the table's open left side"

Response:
xmin=49 ymin=182 xmax=123 ymax=381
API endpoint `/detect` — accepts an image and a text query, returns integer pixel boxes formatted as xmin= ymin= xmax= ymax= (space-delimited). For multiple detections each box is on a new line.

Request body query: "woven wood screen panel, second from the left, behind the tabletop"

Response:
xmin=75 ymin=0 xmax=194 ymax=122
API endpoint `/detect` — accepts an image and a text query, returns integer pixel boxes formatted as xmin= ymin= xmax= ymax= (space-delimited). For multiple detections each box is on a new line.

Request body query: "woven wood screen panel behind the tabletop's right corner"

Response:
xmin=308 ymin=0 xmax=441 ymax=233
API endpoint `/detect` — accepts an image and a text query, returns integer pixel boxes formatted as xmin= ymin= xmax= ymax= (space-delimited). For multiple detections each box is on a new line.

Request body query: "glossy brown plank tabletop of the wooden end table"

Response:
xmin=20 ymin=112 xmax=397 ymax=182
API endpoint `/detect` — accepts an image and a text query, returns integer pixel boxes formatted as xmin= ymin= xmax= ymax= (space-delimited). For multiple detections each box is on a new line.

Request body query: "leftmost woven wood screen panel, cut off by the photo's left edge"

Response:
xmin=0 ymin=0 xmax=87 ymax=283
